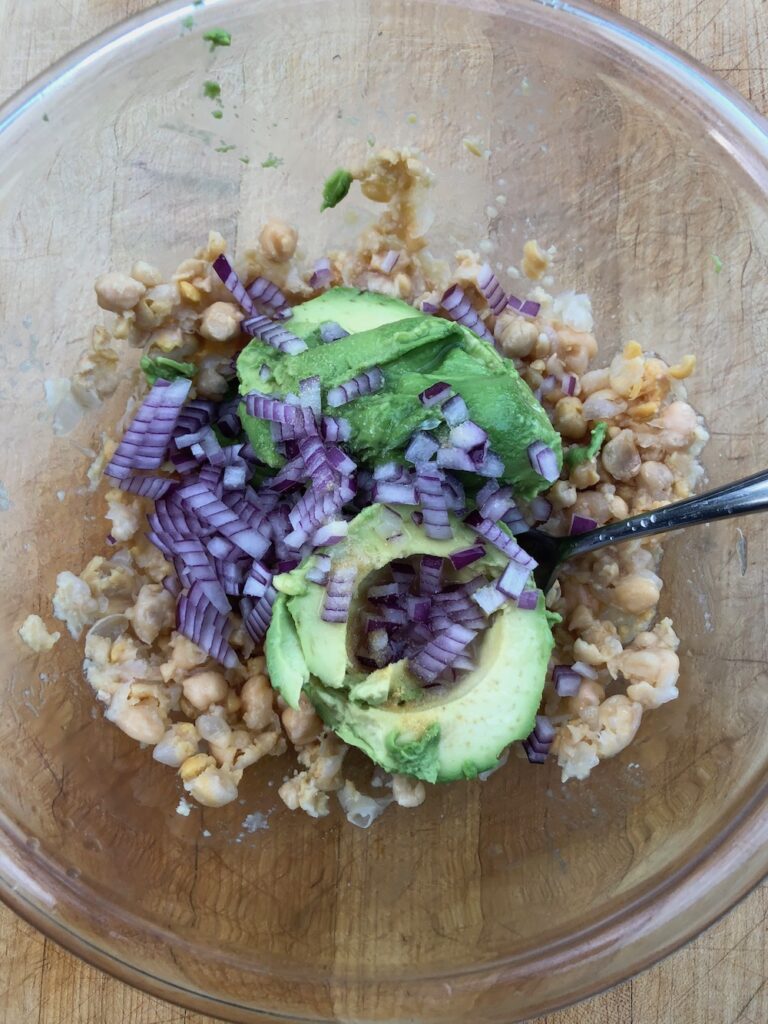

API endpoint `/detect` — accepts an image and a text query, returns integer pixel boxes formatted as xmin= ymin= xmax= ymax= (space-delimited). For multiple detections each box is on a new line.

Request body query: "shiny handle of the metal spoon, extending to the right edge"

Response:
xmin=563 ymin=470 xmax=768 ymax=558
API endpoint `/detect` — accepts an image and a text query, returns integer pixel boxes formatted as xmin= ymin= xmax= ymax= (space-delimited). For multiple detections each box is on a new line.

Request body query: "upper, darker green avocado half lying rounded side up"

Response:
xmin=238 ymin=288 xmax=562 ymax=499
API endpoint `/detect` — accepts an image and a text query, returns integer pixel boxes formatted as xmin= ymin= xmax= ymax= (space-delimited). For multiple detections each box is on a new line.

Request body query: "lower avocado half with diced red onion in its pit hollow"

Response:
xmin=266 ymin=505 xmax=553 ymax=782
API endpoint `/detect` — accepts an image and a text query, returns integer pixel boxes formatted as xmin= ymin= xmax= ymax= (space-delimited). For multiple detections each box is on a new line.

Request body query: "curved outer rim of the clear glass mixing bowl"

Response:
xmin=0 ymin=0 xmax=768 ymax=1024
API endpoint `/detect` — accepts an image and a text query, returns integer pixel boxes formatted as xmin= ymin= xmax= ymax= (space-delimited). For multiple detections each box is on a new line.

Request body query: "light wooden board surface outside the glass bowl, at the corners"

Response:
xmin=0 ymin=0 xmax=768 ymax=1024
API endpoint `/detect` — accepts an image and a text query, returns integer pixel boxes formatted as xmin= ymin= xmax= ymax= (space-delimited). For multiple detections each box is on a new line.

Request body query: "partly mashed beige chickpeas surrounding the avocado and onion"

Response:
xmin=39 ymin=150 xmax=707 ymax=827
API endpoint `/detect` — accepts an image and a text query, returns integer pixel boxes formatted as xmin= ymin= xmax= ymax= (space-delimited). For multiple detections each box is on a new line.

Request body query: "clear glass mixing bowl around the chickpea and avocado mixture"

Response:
xmin=0 ymin=0 xmax=768 ymax=1024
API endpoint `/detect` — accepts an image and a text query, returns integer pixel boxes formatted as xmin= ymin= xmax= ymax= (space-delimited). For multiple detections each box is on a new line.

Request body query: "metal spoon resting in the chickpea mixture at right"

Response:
xmin=515 ymin=470 xmax=768 ymax=592
